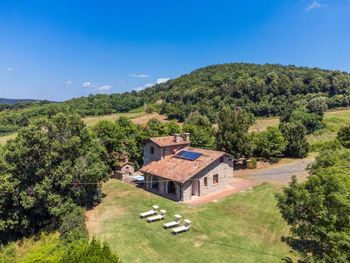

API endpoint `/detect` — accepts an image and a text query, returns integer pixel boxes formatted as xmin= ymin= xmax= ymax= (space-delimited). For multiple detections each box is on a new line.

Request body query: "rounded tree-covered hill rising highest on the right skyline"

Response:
xmin=140 ymin=64 xmax=350 ymax=122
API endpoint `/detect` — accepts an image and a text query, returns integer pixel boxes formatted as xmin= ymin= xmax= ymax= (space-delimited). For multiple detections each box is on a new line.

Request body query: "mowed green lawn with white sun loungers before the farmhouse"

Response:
xmin=87 ymin=179 xmax=292 ymax=262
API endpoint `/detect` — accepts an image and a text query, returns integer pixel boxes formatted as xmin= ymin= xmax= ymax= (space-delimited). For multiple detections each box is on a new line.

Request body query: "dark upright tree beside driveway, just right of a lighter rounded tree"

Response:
xmin=279 ymin=122 xmax=309 ymax=158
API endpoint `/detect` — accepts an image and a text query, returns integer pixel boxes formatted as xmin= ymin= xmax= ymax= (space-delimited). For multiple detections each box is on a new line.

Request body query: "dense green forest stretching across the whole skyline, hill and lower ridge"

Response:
xmin=0 ymin=63 xmax=350 ymax=135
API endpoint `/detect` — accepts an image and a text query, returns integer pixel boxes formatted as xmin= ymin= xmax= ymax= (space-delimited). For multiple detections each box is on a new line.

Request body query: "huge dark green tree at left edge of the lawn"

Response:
xmin=0 ymin=114 xmax=109 ymax=243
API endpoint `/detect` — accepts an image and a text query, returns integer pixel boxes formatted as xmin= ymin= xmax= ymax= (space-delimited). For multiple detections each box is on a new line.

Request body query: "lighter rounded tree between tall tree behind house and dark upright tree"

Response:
xmin=255 ymin=127 xmax=286 ymax=159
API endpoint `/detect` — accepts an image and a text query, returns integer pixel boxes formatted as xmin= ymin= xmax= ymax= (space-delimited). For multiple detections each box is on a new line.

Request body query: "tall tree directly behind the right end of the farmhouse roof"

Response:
xmin=216 ymin=107 xmax=254 ymax=157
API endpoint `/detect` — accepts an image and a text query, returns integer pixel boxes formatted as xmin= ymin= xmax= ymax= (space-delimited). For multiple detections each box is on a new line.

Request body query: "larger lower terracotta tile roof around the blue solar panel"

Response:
xmin=140 ymin=147 xmax=225 ymax=183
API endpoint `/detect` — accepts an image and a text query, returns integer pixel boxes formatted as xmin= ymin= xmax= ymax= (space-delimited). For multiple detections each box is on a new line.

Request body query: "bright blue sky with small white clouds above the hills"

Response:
xmin=0 ymin=0 xmax=350 ymax=100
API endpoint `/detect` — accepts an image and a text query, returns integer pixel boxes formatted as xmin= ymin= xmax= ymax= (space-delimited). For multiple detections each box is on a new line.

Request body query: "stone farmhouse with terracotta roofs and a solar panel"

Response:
xmin=141 ymin=133 xmax=233 ymax=201
